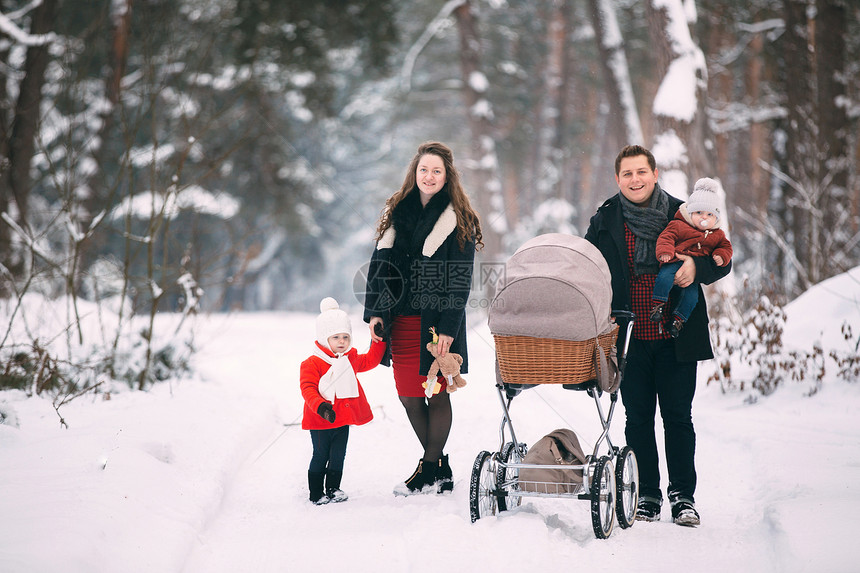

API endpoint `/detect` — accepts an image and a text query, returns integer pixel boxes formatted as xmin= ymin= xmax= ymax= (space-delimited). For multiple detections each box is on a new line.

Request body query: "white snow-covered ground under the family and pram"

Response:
xmin=0 ymin=269 xmax=860 ymax=573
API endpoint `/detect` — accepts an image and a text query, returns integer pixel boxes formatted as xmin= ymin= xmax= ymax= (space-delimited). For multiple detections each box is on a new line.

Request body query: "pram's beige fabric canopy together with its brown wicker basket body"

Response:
xmin=489 ymin=233 xmax=620 ymax=396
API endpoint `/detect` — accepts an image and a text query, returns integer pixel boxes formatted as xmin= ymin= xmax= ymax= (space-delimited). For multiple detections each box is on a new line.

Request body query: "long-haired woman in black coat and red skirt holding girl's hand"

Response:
xmin=364 ymin=142 xmax=483 ymax=495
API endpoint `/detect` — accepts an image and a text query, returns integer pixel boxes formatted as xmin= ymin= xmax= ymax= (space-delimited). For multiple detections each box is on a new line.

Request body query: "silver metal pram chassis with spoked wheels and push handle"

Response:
xmin=469 ymin=311 xmax=639 ymax=539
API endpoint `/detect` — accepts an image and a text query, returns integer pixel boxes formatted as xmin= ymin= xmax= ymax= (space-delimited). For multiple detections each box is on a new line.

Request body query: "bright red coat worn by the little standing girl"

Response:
xmin=299 ymin=342 xmax=385 ymax=430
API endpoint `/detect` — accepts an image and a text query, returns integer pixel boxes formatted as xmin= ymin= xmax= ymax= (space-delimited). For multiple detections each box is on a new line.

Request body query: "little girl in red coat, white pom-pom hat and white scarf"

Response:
xmin=299 ymin=297 xmax=385 ymax=505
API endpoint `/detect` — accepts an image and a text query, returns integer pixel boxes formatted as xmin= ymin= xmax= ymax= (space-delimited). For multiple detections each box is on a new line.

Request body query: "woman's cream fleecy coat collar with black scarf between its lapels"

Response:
xmin=376 ymin=189 xmax=457 ymax=257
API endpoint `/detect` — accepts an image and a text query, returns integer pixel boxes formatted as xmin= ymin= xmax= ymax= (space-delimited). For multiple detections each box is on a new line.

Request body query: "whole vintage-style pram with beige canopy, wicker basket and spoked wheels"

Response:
xmin=469 ymin=233 xmax=639 ymax=539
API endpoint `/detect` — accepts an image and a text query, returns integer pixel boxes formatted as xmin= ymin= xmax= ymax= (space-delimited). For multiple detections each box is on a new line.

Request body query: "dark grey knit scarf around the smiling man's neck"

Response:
xmin=618 ymin=183 xmax=669 ymax=275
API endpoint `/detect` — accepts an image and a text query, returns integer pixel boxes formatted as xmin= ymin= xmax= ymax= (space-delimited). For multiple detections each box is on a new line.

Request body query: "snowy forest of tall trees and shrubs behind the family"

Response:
xmin=0 ymin=0 xmax=860 ymax=393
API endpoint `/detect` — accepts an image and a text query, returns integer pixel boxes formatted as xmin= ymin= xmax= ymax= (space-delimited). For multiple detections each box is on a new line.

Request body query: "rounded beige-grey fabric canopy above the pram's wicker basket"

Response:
xmin=489 ymin=233 xmax=613 ymax=341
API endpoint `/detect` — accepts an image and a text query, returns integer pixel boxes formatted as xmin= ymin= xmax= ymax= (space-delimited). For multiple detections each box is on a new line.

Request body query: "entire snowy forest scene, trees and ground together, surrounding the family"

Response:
xmin=0 ymin=0 xmax=860 ymax=573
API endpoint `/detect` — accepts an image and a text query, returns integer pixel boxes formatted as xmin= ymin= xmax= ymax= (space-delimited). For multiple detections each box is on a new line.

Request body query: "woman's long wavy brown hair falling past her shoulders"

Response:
xmin=376 ymin=141 xmax=484 ymax=250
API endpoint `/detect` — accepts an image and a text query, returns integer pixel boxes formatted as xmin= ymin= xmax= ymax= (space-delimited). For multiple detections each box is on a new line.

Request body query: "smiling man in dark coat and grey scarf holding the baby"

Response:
xmin=585 ymin=145 xmax=731 ymax=526
